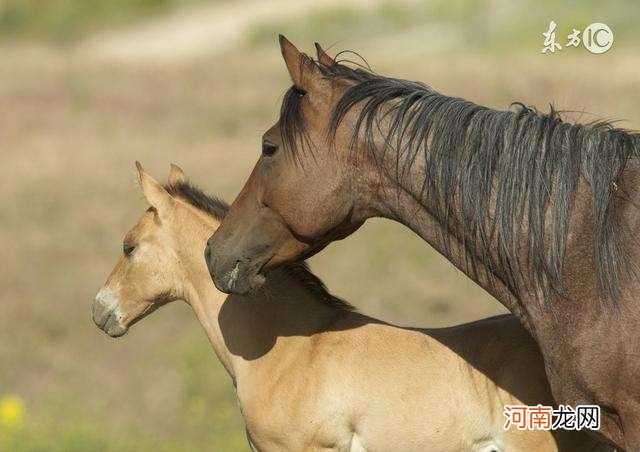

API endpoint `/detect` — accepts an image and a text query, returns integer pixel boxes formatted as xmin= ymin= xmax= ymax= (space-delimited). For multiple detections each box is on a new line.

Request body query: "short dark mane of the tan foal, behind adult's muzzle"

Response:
xmin=164 ymin=181 xmax=355 ymax=311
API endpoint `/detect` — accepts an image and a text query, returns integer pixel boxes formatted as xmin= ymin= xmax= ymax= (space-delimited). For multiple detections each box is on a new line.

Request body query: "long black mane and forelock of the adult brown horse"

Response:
xmin=280 ymin=58 xmax=640 ymax=301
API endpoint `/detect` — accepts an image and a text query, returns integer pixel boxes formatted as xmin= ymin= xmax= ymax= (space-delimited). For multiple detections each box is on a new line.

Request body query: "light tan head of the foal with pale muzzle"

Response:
xmin=92 ymin=164 xmax=226 ymax=337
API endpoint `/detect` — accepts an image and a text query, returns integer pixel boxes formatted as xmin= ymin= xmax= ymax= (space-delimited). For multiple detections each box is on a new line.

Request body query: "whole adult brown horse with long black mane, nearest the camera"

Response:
xmin=205 ymin=37 xmax=640 ymax=450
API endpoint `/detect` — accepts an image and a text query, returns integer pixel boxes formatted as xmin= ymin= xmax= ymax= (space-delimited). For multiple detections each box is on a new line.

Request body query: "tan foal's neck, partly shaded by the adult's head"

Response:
xmin=187 ymin=268 xmax=341 ymax=383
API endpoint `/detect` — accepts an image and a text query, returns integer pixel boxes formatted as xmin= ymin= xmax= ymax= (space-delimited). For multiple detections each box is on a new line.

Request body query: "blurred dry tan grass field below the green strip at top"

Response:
xmin=0 ymin=26 xmax=640 ymax=450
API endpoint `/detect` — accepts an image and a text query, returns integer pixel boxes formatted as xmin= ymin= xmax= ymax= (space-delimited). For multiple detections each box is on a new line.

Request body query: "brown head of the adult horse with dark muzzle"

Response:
xmin=205 ymin=37 xmax=371 ymax=293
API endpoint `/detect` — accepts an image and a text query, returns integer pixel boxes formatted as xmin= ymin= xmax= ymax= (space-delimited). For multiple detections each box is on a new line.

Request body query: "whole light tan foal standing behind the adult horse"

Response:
xmin=93 ymin=166 xmax=604 ymax=452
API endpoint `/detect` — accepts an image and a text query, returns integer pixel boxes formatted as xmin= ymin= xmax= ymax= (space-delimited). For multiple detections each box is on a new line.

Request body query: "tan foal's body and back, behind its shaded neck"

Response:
xmin=248 ymin=313 xmax=608 ymax=452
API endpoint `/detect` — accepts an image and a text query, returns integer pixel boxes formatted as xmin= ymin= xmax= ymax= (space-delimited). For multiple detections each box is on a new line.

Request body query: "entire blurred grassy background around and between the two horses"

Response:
xmin=0 ymin=0 xmax=640 ymax=451
